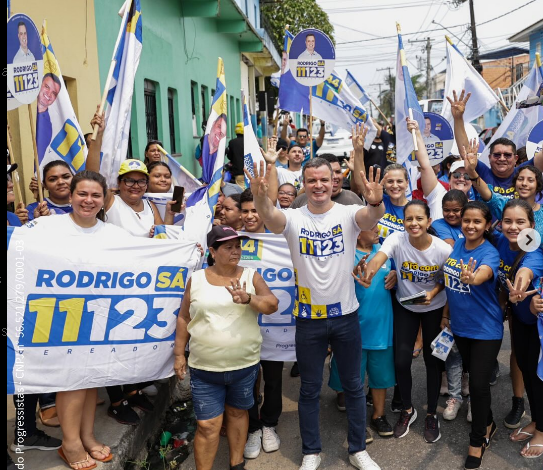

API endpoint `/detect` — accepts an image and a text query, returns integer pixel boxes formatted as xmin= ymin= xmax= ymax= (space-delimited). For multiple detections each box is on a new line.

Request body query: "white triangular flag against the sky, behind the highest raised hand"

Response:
xmin=441 ymin=38 xmax=499 ymax=122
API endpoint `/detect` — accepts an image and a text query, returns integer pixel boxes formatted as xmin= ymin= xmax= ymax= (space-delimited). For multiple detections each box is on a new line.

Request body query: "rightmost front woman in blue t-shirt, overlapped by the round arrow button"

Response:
xmin=497 ymin=199 xmax=543 ymax=458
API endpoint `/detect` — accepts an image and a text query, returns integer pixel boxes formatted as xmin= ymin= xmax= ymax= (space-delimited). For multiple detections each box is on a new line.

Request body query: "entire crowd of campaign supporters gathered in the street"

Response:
xmin=7 ymin=92 xmax=543 ymax=470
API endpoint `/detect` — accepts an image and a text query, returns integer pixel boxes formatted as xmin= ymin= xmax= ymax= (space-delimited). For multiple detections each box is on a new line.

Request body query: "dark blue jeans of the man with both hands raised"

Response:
xmin=296 ymin=312 xmax=366 ymax=455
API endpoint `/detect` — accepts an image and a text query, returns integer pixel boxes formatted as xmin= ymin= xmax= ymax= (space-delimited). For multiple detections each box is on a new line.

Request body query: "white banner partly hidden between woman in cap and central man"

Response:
xmin=239 ymin=232 xmax=296 ymax=362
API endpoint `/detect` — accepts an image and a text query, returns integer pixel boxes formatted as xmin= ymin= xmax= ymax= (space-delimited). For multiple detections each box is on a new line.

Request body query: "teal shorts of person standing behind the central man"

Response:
xmin=328 ymin=346 xmax=396 ymax=392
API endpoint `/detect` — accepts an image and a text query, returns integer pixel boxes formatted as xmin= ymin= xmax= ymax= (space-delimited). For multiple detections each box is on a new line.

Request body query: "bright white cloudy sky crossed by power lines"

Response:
xmin=315 ymin=0 xmax=543 ymax=99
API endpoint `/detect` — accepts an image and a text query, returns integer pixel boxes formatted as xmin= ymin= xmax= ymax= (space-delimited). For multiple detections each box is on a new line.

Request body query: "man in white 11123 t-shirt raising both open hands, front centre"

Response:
xmin=249 ymin=158 xmax=384 ymax=470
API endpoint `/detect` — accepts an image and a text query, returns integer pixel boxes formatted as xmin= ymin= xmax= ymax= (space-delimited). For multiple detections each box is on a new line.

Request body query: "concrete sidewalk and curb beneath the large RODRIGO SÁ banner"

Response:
xmin=7 ymin=378 xmax=190 ymax=470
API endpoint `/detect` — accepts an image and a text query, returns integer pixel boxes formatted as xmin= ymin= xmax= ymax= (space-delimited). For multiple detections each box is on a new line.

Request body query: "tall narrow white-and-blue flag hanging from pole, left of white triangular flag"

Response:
xmin=395 ymin=25 xmax=424 ymax=165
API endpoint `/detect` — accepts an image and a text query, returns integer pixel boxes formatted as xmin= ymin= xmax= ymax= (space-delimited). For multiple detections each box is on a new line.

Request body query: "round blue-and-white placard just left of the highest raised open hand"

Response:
xmin=409 ymin=113 xmax=454 ymax=166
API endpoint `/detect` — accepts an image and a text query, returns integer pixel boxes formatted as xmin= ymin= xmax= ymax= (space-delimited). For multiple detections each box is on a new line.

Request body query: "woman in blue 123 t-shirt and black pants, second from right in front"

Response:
xmin=443 ymin=201 xmax=503 ymax=469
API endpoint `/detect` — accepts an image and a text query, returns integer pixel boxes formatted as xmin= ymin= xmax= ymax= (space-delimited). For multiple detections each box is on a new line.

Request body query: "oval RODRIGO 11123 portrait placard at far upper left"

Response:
xmin=6 ymin=14 xmax=43 ymax=104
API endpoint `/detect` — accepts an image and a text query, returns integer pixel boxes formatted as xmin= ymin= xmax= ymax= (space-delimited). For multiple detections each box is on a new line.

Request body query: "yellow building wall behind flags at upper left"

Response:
xmin=7 ymin=0 xmax=101 ymax=204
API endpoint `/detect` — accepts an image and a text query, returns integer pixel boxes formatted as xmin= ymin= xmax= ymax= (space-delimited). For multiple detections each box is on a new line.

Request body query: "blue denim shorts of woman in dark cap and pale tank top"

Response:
xmin=190 ymin=363 xmax=260 ymax=421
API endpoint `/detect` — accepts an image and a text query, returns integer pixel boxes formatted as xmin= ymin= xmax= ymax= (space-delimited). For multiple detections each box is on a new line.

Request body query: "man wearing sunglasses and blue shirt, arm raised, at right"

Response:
xmin=447 ymin=90 xmax=543 ymax=199
